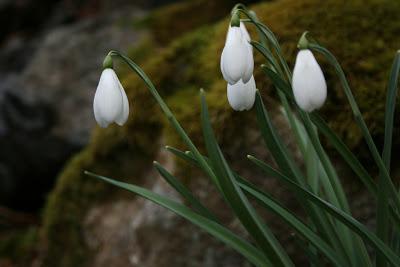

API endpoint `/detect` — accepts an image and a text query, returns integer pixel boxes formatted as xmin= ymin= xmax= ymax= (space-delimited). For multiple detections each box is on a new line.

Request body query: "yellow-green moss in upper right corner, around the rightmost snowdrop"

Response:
xmin=252 ymin=0 xmax=400 ymax=149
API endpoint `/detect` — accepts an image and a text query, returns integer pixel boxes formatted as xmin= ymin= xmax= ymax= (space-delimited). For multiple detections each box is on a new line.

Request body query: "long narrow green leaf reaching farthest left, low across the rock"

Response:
xmin=85 ymin=171 xmax=273 ymax=267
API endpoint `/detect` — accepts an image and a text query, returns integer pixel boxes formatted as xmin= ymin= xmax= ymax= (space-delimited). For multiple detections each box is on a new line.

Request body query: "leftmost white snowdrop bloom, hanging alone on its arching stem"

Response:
xmin=93 ymin=68 xmax=129 ymax=128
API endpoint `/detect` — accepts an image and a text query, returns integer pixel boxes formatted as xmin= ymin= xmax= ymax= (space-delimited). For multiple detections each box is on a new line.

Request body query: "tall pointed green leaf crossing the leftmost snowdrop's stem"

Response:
xmin=201 ymin=91 xmax=294 ymax=266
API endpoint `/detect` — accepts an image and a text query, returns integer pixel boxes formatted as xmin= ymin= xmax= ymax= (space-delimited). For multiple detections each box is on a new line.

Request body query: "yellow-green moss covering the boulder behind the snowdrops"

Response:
xmin=41 ymin=0 xmax=400 ymax=267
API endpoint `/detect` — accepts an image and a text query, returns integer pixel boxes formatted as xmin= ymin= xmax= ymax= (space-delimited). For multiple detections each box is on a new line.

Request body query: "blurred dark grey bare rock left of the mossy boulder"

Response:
xmin=0 ymin=3 xmax=144 ymax=211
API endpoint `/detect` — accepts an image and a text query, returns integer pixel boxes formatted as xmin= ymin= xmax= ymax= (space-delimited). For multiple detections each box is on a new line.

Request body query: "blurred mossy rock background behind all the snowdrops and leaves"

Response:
xmin=0 ymin=0 xmax=400 ymax=267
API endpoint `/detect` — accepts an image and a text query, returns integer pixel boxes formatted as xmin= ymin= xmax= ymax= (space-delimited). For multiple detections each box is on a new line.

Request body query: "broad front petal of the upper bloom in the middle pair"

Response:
xmin=221 ymin=27 xmax=251 ymax=84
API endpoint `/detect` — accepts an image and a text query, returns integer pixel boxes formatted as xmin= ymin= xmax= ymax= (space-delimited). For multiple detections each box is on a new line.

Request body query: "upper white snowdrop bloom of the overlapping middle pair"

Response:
xmin=221 ymin=22 xmax=254 ymax=85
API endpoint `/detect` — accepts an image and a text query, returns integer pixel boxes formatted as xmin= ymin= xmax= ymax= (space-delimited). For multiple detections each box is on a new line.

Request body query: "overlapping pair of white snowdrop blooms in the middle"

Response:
xmin=221 ymin=11 xmax=256 ymax=111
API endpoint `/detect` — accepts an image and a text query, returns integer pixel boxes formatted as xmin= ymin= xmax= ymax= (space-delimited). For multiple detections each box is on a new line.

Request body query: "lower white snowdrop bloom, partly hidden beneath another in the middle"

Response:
xmin=227 ymin=75 xmax=256 ymax=111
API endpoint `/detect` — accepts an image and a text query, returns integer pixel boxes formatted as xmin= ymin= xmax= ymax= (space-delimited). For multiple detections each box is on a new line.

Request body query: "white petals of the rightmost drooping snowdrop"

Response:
xmin=292 ymin=49 xmax=327 ymax=112
